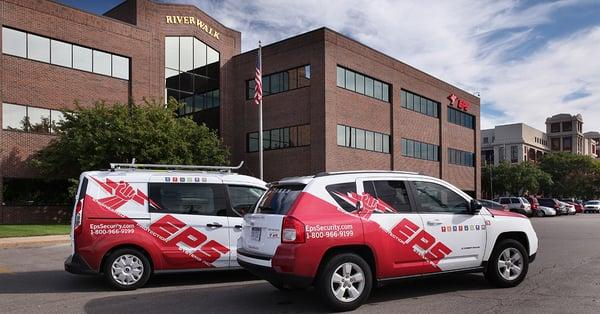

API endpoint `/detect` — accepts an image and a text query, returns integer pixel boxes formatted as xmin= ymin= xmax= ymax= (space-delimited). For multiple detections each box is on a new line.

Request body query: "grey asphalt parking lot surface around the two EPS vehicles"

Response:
xmin=0 ymin=214 xmax=600 ymax=313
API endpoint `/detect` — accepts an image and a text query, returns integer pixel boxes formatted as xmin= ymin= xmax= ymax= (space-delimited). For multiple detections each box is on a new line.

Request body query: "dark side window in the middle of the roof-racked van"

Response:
xmin=148 ymin=183 xmax=227 ymax=216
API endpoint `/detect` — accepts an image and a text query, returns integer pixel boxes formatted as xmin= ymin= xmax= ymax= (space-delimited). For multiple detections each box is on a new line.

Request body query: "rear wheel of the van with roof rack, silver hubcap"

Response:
xmin=104 ymin=249 xmax=152 ymax=290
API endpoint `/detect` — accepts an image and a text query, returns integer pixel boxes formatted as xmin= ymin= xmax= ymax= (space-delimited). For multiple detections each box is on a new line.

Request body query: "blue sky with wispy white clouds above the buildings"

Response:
xmin=60 ymin=0 xmax=600 ymax=131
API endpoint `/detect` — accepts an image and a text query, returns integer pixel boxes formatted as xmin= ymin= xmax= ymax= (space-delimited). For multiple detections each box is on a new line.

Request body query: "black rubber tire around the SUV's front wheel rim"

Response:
xmin=485 ymin=239 xmax=529 ymax=288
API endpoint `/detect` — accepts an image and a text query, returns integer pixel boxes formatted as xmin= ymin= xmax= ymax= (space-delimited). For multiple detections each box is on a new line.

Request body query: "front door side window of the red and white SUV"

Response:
xmin=414 ymin=181 xmax=469 ymax=214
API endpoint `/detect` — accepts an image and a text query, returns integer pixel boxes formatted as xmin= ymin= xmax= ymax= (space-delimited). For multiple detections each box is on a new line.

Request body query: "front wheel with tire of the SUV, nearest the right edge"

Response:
xmin=485 ymin=239 xmax=529 ymax=288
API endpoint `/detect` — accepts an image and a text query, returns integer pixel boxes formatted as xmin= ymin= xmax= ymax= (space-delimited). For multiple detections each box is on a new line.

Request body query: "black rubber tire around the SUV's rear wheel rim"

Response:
xmin=315 ymin=253 xmax=373 ymax=311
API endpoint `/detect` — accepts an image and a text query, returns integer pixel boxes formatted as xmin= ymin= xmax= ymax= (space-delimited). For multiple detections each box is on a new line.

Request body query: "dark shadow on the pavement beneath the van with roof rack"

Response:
xmin=0 ymin=270 xmax=257 ymax=294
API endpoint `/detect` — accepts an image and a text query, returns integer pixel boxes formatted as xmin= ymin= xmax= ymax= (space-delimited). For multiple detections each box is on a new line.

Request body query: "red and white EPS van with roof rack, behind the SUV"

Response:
xmin=65 ymin=164 xmax=266 ymax=290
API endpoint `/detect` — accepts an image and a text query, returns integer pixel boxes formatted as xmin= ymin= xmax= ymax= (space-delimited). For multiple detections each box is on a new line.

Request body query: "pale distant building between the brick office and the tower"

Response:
xmin=481 ymin=123 xmax=549 ymax=165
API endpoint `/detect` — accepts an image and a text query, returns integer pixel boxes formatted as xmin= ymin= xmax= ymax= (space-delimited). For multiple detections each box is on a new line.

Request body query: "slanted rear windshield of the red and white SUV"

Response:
xmin=256 ymin=184 xmax=305 ymax=215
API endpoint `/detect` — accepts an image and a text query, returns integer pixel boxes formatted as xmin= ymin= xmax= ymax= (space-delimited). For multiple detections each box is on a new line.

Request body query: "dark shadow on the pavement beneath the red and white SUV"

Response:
xmin=85 ymin=274 xmax=492 ymax=313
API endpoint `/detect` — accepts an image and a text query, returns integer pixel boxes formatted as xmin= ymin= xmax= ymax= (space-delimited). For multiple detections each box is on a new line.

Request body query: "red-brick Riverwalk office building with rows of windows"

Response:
xmin=0 ymin=0 xmax=480 ymax=221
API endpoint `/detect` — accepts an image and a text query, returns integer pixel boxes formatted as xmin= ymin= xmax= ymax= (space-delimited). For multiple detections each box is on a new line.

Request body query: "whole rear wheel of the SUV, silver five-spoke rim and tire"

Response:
xmin=315 ymin=253 xmax=373 ymax=311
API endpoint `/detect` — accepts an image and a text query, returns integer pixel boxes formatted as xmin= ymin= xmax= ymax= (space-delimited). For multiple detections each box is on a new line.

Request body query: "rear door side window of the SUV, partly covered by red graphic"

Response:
xmin=364 ymin=181 xmax=411 ymax=213
